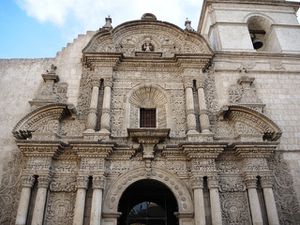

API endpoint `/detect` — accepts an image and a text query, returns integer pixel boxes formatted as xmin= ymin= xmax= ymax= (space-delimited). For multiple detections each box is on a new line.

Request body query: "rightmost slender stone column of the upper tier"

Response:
xmin=197 ymin=80 xmax=210 ymax=133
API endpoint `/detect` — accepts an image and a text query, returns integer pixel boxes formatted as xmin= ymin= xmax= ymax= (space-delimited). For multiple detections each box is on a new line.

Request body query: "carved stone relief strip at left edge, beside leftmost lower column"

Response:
xmin=0 ymin=152 xmax=24 ymax=225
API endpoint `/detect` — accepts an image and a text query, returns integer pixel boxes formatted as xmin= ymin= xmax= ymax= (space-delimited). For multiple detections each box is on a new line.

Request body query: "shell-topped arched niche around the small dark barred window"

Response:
xmin=129 ymin=86 xmax=167 ymax=128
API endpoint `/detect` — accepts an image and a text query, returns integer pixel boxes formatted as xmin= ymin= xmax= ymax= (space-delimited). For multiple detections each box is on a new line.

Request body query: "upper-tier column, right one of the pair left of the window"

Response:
xmin=100 ymin=78 xmax=113 ymax=134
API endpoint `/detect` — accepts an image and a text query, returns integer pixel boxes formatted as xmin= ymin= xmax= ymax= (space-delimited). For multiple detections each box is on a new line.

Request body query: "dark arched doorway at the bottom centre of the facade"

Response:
xmin=118 ymin=179 xmax=178 ymax=225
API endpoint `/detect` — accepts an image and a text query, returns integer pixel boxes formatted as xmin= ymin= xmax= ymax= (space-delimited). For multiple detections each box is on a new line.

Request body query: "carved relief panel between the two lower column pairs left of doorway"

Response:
xmin=45 ymin=192 xmax=76 ymax=225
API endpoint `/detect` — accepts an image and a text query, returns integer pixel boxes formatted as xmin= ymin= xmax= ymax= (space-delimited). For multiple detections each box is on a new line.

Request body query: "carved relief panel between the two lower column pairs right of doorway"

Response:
xmin=220 ymin=192 xmax=252 ymax=225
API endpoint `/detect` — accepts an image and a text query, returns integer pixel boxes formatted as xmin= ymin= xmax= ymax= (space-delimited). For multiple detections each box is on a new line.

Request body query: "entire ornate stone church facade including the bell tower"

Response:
xmin=0 ymin=0 xmax=300 ymax=225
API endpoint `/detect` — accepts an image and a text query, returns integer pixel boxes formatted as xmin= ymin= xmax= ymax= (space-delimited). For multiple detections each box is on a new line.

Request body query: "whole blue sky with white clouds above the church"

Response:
xmin=0 ymin=0 xmax=299 ymax=58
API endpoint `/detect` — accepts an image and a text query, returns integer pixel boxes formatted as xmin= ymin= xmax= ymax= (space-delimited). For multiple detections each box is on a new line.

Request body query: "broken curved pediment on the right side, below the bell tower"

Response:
xmin=217 ymin=105 xmax=282 ymax=141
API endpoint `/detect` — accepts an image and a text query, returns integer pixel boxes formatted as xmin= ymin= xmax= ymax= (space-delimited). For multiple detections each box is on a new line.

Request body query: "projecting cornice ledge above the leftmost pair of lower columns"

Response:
xmin=16 ymin=140 xmax=67 ymax=159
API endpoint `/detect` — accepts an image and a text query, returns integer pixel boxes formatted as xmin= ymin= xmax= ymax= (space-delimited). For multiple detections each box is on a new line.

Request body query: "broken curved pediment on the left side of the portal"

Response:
xmin=12 ymin=104 xmax=70 ymax=139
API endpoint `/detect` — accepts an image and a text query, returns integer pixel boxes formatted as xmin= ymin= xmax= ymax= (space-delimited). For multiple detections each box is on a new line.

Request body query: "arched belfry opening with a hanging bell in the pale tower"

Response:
xmin=247 ymin=15 xmax=278 ymax=52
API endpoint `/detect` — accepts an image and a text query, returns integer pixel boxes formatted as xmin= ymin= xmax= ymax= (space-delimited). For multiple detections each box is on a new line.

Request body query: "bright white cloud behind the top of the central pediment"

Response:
xmin=16 ymin=0 xmax=202 ymax=30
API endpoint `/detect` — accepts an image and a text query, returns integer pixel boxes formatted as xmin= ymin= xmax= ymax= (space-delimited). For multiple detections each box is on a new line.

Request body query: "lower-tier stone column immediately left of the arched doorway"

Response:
xmin=90 ymin=176 xmax=104 ymax=225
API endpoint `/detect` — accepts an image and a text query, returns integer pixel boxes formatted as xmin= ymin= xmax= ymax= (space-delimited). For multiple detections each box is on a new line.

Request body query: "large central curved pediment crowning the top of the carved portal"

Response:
xmin=83 ymin=14 xmax=213 ymax=57
